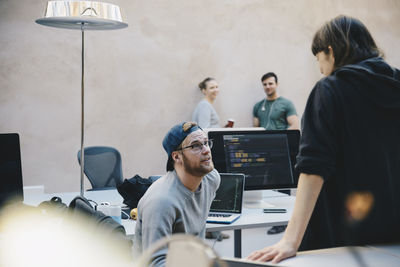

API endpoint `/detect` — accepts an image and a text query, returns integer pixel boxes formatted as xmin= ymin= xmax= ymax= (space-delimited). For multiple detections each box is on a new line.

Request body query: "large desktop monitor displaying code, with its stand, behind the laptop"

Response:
xmin=208 ymin=128 xmax=300 ymax=209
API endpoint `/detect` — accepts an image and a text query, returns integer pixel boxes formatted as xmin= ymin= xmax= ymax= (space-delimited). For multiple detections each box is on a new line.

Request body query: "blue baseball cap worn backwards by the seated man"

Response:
xmin=163 ymin=122 xmax=202 ymax=171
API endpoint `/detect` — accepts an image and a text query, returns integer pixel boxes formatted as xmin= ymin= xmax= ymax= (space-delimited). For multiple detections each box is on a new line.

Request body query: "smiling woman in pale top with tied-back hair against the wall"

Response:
xmin=192 ymin=77 xmax=221 ymax=129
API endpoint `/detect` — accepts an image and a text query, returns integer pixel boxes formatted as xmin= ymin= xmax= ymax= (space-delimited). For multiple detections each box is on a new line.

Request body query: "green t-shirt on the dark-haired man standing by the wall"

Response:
xmin=253 ymin=96 xmax=297 ymax=130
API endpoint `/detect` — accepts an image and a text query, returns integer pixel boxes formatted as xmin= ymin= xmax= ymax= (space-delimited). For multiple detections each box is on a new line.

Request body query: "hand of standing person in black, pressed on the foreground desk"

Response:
xmin=247 ymin=239 xmax=297 ymax=263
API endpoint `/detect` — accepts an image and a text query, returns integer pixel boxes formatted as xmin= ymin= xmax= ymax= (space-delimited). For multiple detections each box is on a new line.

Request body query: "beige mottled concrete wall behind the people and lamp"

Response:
xmin=0 ymin=0 xmax=400 ymax=192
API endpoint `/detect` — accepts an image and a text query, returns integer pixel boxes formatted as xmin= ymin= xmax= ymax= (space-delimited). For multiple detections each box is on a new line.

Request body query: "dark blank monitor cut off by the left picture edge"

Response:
xmin=0 ymin=133 xmax=23 ymax=208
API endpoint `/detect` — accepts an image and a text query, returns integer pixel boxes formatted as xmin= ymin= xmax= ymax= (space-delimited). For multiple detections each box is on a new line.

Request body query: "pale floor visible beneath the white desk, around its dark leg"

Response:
xmin=206 ymin=227 xmax=283 ymax=258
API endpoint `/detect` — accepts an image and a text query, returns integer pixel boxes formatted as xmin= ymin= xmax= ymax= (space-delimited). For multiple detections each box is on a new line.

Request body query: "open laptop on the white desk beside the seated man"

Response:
xmin=207 ymin=173 xmax=244 ymax=224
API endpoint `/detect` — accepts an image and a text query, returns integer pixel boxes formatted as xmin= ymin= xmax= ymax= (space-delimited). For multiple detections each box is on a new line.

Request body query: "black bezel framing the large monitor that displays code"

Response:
xmin=207 ymin=128 xmax=300 ymax=190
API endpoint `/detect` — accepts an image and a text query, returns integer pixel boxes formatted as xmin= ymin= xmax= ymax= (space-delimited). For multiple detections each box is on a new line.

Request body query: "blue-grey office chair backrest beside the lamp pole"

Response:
xmin=78 ymin=146 xmax=123 ymax=191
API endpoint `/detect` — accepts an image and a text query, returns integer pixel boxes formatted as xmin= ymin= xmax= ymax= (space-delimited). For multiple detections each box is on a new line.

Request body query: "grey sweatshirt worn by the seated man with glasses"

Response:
xmin=134 ymin=169 xmax=221 ymax=266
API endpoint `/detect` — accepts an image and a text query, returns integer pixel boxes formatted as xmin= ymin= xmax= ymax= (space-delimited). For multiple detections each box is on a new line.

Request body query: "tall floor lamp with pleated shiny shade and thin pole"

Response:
xmin=36 ymin=1 xmax=128 ymax=197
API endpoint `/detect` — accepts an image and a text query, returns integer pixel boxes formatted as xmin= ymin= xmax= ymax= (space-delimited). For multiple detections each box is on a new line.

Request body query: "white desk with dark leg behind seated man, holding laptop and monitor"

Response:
xmin=24 ymin=190 xmax=295 ymax=258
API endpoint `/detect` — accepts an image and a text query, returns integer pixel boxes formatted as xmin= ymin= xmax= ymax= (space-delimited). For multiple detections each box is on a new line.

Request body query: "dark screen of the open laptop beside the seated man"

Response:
xmin=210 ymin=173 xmax=244 ymax=216
